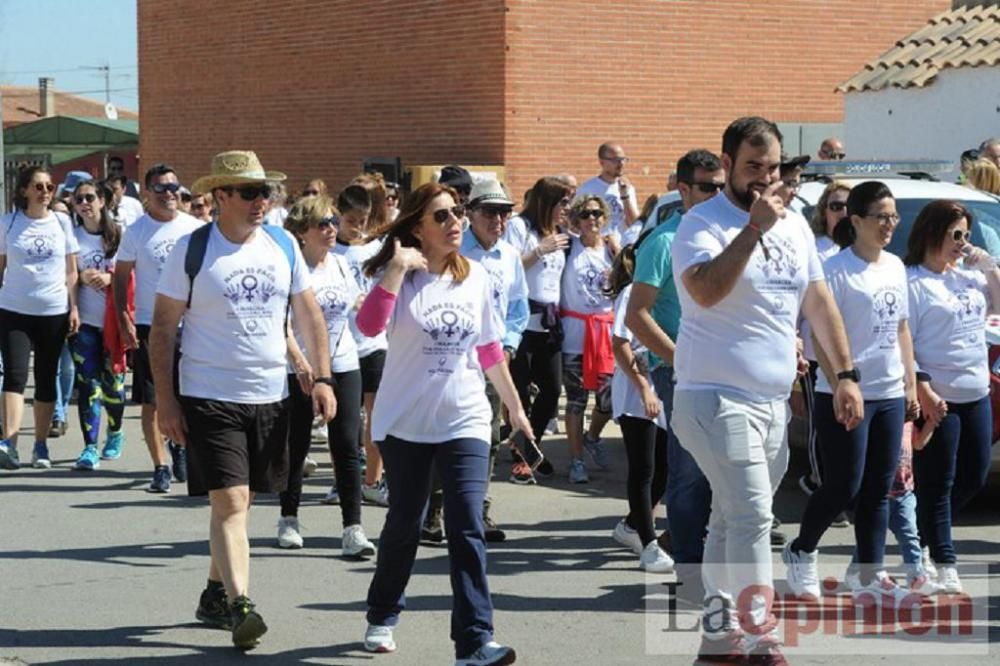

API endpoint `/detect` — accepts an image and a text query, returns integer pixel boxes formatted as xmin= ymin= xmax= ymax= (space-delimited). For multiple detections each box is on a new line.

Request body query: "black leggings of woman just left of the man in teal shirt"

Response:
xmin=618 ymin=416 xmax=667 ymax=546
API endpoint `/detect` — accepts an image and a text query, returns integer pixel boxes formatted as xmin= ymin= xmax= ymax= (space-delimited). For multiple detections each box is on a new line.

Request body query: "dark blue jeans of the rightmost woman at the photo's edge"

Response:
xmin=913 ymin=396 xmax=993 ymax=564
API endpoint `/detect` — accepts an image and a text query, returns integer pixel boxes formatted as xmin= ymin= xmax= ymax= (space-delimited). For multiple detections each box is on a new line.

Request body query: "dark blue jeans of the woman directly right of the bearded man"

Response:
xmin=791 ymin=393 xmax=906 ymax=583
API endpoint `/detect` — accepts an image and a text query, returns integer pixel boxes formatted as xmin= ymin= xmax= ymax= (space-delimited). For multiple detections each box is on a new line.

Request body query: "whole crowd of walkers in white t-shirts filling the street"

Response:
xmin=0 ymin=117 xmax=1000 ymax=665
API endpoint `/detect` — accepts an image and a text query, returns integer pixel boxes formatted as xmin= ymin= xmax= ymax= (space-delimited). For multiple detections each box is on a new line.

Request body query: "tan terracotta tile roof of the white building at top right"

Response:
xmin=837 ymin=3 xmax=1000 ymax=92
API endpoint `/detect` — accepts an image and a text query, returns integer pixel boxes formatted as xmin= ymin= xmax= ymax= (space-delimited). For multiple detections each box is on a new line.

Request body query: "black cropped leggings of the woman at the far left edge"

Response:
xmin=0 ymin=309 xmax=69 ymax=402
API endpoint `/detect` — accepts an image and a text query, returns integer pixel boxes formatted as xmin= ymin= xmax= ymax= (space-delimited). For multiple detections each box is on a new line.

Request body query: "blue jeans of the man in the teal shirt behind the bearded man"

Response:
xmin=651 ymin=365 xmax=712 ymax=564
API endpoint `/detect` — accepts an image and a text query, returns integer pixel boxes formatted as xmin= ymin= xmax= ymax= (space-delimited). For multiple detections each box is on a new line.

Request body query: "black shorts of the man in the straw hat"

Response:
xmin=180 ymin=396 xmax=288 ymax=495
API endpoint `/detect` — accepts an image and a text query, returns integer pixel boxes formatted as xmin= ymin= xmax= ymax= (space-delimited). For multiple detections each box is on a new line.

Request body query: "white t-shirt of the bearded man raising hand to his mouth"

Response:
xmin=671 ymin=193 xmax=823 ymax=402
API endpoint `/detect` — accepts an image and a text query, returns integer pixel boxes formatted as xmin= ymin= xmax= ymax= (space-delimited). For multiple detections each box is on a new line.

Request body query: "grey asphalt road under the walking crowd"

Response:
xmin=0 ymin=392 xmax=1000 ymax=666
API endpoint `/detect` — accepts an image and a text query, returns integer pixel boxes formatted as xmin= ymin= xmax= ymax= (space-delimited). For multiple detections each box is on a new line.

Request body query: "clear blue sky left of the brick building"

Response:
xmin=0 ymin=0 xmax=139 ymax=110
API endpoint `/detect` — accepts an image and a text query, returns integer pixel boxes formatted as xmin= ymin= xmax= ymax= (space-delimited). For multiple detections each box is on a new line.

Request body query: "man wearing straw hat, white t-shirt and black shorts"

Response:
xmin=150 ymin=151 xmax=336 ymax=649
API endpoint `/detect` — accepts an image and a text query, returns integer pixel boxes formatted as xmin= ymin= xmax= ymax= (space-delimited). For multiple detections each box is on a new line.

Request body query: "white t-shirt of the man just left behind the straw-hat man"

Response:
xmin=117 ymin=212 xmax=203 ymax=326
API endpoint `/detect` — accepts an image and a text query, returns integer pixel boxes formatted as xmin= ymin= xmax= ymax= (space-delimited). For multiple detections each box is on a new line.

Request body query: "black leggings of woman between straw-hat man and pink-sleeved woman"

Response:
xmin=281 ymin=370 xmax=361 ymax=527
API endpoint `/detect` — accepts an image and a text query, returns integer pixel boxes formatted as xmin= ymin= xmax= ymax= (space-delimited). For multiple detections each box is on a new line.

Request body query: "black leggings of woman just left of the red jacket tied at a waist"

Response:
xmin=510 ymin=331 xmax=562 ymax=443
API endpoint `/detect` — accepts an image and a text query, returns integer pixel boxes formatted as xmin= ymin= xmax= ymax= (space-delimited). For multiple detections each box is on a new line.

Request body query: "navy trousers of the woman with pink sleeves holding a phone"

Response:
xmin=368 ymin=435 xmax=493 ymax=658
